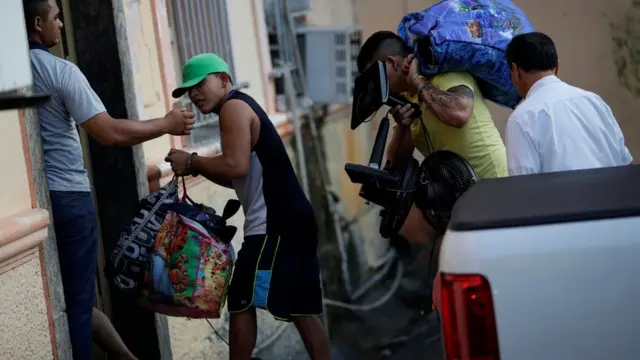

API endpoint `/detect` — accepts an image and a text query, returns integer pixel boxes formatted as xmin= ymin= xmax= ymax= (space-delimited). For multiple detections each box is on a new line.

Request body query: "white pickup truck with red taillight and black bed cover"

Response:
xmin=436 ymin=165 xmax=640 ymax=360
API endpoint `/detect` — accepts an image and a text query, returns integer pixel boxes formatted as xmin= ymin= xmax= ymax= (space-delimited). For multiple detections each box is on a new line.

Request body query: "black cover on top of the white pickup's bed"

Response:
xmin=449 ymin=165 xmax=640 ymax=231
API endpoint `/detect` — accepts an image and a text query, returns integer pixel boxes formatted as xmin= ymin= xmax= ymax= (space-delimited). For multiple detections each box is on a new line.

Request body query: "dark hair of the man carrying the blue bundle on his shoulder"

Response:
xmin=358 ymin=31 xmax=412 ymax=73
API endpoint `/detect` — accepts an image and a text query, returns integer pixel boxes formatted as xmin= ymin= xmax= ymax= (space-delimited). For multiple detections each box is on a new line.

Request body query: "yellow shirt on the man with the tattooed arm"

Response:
xmin=408 ymin=72 xmax=508 ymax=179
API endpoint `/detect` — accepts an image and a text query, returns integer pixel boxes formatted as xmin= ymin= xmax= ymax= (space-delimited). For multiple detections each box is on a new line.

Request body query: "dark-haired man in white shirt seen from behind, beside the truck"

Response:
xmin=505 ymin=32 xmax=632 ymax=175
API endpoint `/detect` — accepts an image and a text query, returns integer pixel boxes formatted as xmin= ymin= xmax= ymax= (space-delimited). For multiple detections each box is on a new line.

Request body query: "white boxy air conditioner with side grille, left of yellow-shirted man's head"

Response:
xmin=296 ymin=26 xmax=362 ymax=104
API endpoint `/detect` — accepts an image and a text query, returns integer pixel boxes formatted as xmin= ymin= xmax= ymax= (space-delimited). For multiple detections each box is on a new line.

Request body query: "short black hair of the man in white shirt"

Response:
xmin=507 ymin=32 xmax=558 ymax=72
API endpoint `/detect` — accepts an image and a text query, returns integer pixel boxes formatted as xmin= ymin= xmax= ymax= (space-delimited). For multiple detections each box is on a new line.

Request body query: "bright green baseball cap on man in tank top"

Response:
xmin=171 ymin=53 xmax=231 ymax=99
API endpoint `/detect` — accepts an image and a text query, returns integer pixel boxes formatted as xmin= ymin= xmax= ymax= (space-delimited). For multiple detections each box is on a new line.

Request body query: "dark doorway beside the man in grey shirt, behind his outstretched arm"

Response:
xmin=52 ymin=0 xmax=171 ymax=360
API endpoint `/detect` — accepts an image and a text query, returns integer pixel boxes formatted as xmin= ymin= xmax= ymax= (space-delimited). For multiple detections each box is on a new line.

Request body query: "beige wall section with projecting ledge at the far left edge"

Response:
xmin=0 ymin=111 xmax=57 ymax=359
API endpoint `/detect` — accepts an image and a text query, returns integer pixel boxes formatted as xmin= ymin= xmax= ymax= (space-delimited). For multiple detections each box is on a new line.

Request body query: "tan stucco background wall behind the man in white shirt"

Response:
xmin=354 ymin=0 xmax=640 ymax=161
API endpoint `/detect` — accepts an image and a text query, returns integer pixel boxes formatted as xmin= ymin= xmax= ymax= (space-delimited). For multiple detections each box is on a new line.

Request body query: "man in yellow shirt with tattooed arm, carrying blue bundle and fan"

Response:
xmin=358 ymin=31 xmax=508 ymax=310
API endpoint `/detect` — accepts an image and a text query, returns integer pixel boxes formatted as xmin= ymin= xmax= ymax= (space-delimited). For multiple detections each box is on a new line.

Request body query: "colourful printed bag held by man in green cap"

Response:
xmin=142 ymin=195 xmax=239 ymax=319
